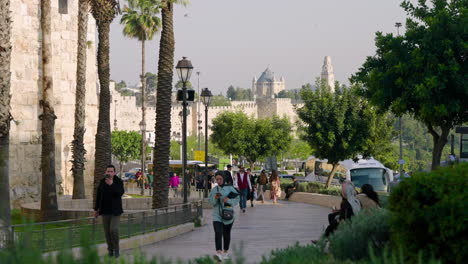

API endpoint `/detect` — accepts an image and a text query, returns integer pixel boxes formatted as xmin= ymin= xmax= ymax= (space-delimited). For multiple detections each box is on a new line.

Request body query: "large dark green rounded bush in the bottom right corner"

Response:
xmin=388 ymin=163 xmax=468 ymax=263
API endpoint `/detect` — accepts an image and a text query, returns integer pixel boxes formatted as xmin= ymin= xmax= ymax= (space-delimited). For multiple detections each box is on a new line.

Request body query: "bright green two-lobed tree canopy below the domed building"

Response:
xmin=211 ymin=112 xmax=292 ymax=164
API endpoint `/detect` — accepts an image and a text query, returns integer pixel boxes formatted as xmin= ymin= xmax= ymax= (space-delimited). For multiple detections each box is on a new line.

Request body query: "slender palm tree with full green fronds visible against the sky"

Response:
xmin=120 ymin=0 xmax=161 ymax=195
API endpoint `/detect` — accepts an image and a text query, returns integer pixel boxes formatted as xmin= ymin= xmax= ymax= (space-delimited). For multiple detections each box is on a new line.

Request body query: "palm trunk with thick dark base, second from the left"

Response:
xmin=39 ymin=0 xmax=58 ymax=221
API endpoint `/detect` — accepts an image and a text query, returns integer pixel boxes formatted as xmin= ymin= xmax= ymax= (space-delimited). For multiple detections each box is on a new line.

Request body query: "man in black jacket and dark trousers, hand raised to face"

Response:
xmin=94 ymin=165 xmax=125 ymax=258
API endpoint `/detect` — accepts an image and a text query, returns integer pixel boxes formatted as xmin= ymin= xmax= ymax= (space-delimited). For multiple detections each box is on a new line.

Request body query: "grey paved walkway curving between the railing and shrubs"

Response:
xmin=124 ymin=201 xmax=330 ymax=263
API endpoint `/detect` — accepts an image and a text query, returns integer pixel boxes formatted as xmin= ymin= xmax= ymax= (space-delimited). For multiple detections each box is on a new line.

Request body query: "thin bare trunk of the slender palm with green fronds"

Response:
xmin=140 ymin=40 xmax=146 ymax=195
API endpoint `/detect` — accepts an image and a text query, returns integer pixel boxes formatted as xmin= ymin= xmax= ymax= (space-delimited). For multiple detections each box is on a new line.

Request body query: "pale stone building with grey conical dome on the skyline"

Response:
xmin=252 ymin=67 xmax=285 ymax=99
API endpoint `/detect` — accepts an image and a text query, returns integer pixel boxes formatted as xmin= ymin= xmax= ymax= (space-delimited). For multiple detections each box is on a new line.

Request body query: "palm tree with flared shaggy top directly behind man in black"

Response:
xmin=91 ymin=0 xmax=119 ymax=200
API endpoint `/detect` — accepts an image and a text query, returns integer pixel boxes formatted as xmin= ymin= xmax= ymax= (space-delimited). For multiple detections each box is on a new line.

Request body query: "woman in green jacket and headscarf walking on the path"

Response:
xmin=208 ymin=174 xmax=239 ymax=261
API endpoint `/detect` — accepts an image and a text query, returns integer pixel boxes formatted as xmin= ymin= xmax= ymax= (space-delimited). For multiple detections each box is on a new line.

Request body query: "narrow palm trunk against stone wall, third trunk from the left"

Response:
xmin=72 ymin=0 xmax=89 ymax=199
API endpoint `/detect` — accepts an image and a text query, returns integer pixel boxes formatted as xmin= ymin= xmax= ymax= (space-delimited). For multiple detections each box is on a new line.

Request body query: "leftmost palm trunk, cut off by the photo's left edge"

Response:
xmin=0 ymin=0 xmax=11 ymax=243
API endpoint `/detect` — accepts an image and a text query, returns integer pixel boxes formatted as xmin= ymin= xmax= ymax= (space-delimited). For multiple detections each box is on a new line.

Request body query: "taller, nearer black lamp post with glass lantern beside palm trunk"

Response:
xmin=176 ymin=57 xmax=193 ymax=203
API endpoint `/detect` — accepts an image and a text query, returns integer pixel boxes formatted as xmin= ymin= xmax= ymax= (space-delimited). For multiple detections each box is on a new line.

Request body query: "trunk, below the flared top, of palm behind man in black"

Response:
xmin=93 ymin=20 xmax=112 ymax=201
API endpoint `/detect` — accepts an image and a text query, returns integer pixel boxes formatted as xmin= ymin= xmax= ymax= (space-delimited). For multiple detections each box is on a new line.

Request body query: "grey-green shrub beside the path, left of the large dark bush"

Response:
xmin=329 ymin=209 xmax=390 ymax=260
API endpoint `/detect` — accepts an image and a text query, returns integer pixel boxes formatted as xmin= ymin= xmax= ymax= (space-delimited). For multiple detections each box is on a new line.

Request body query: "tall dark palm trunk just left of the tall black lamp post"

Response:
xmin=153 ymin=0 xmax=175 ymax=208
